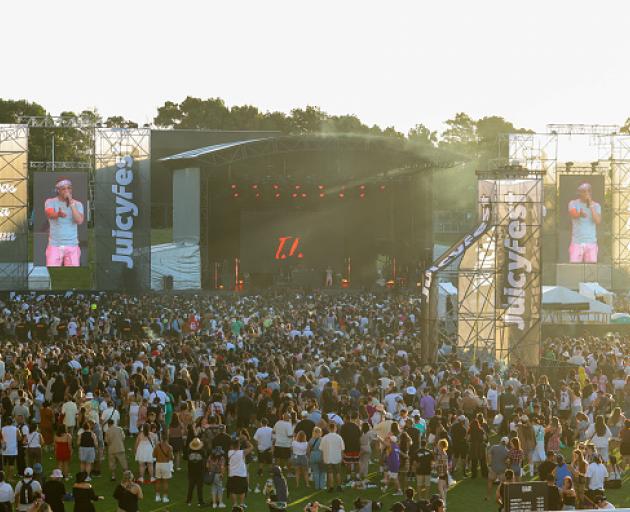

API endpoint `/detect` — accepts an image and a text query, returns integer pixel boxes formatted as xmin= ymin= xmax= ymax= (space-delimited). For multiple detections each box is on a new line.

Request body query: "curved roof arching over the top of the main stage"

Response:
xmin=160 ymin=134 xmax=466 ymax=168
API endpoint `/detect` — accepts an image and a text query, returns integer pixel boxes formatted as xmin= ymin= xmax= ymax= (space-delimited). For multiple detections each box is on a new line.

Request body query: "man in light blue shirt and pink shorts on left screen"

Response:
xmin=44 ymin=178 xmax=84 ymax=267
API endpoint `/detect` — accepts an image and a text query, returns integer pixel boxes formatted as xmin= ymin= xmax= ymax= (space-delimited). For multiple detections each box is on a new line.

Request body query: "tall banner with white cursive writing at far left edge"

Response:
xmin=0 ymin=124 xmax=28 ymax=290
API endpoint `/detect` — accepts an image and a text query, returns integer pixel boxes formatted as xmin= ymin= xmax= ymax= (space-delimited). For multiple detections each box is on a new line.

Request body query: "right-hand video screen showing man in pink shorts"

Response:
xmin=558 ymin=174 xmax=610 ymax=264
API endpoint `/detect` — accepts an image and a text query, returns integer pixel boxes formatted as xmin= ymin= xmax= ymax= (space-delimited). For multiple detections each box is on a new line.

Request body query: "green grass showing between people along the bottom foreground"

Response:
xmin=33 ymin=439 xmax=630 ymax=512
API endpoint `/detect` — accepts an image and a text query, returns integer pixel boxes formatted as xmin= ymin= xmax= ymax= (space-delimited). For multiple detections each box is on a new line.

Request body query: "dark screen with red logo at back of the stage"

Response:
xmin=240 ymin=209 xmax=344 ymax=273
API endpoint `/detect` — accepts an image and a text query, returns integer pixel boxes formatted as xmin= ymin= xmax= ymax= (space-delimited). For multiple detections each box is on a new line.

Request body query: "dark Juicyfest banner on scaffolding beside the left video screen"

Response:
xmin=94 ymin=128 xmax=151 ymax=292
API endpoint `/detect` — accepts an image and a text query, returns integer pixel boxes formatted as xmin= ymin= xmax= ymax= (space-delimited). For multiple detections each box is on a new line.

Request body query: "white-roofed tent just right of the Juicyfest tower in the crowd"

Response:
xmin=543 ymin=286 xmax=613 ymax=324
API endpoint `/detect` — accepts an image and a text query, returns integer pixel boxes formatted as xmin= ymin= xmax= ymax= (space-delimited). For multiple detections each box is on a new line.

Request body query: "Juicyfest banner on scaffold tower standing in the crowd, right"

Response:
xmin=488 ymin=176 xmax=543 ymax=366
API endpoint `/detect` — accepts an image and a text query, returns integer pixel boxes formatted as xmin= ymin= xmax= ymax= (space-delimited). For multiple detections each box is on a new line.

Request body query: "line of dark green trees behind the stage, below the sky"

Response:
xmin=0 ymin=96 xmax=630 ymax=161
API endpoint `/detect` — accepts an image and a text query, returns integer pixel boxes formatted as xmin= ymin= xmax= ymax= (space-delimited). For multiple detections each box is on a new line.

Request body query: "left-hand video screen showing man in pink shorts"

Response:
xmin=33 ymin=172 xmax=88 ymax=267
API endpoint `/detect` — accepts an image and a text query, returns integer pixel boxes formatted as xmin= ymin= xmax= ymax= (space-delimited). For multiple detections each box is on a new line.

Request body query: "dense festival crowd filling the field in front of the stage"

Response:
xmin=0 ymin=292 xmax=630 ymax=512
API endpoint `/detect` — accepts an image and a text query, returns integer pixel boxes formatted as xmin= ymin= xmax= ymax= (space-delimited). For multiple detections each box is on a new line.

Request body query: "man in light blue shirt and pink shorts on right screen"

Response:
xmin=569 ymin=183 xmax=602 ymax=263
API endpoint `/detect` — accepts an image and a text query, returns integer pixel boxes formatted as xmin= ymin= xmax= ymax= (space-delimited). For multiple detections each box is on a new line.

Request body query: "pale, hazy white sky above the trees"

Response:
xmin=0 ymin=0 xmax=630 ymax=131
